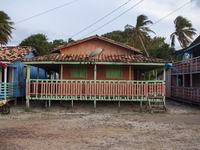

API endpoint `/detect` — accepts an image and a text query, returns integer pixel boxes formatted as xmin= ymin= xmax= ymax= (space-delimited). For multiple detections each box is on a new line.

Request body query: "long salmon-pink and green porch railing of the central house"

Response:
xmin=26 ymin=79 xmax=165 ymax=100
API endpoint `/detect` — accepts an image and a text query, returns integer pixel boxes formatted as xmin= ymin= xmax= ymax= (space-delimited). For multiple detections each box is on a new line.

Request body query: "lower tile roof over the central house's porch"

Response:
xmin=22 ymin=53 xmax=171 ymax=63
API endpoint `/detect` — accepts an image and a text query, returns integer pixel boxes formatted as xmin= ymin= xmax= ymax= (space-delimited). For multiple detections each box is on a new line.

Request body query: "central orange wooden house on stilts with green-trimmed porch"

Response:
xmin=23 ymin=35 xmax=169 ymax=112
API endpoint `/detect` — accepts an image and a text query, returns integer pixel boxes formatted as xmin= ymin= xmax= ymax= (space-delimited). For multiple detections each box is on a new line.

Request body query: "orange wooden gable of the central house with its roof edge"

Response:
xmin=51 ymin=35 xmax=142 ymax=55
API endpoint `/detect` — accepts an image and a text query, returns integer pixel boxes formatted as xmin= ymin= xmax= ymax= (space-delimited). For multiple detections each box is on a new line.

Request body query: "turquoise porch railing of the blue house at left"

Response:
xmin=0 ymin=82 xmax=17 ymax=99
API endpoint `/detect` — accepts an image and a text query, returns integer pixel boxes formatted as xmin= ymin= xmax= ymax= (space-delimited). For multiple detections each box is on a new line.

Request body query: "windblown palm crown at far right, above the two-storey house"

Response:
xmin=170 ymin=16 xmax=196 ymax=48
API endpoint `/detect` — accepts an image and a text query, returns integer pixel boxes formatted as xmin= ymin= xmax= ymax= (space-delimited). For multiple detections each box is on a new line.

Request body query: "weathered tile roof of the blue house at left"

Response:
xmin=0 ymin=46 xmax=39 ymax=62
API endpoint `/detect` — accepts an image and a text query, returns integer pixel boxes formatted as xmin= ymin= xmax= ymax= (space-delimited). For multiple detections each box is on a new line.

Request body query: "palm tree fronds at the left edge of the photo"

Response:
xmin=0 ymin=11 xmax=15 ymax=46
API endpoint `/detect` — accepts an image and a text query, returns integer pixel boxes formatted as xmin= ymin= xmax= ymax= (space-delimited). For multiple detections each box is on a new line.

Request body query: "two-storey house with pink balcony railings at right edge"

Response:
xmin=171 ymin=36 xmax=200 ymax=105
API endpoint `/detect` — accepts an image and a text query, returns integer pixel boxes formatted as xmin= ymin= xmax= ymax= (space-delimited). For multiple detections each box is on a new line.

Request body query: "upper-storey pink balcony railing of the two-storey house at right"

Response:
xmin=172 ymin=57 xmax=200 ymax=73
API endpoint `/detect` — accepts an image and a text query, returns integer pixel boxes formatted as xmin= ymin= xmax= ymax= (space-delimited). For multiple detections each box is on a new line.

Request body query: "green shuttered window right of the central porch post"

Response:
xmin=106 ymin=65 xmax=122 ymax=78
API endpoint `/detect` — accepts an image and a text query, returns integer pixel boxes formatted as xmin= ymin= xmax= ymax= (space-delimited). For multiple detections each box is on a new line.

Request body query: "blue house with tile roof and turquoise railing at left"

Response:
xmin=0 ymin=46 xmax=46 ymax=104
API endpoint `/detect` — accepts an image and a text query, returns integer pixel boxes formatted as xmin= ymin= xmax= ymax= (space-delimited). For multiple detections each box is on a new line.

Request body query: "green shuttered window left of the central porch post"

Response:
xmin=71 ymin=65 xmax=87 ymax=78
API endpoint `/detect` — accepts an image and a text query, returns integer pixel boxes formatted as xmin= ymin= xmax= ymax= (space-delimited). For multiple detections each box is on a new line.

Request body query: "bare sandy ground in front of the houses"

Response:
xmin=0 ymin=100 xmax=200 ymax=150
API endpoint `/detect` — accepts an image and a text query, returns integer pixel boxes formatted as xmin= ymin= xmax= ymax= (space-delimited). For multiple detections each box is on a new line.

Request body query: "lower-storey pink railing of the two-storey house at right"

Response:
xmin=171 ymin=86 xmax=200 ymax=103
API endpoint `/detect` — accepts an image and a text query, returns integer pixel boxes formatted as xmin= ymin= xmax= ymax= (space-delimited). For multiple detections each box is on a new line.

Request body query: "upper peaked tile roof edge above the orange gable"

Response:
xmin=50 ymin=35 xmax=142 ymax=54
